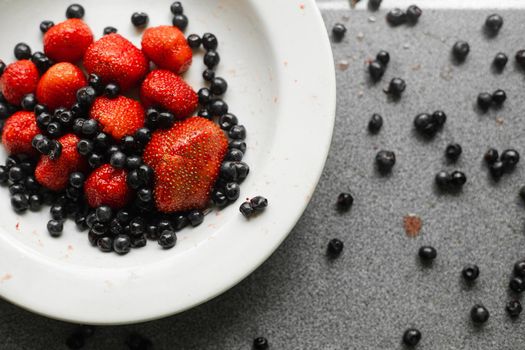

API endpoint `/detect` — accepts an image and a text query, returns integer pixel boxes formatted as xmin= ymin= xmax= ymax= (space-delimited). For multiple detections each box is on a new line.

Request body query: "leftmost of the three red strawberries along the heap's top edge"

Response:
xmin=44 ymin=18 xmax=93 ymax=62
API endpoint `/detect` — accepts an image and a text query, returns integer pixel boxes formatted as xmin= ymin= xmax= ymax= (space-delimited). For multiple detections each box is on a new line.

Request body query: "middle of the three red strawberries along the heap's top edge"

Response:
xmin=84 ymin=34 xmax=148 ymax=91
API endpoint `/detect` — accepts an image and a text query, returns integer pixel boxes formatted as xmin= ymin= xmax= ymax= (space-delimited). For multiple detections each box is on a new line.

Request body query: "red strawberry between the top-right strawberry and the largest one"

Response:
xmin=140 ymin=69 xmax=198 ymax=119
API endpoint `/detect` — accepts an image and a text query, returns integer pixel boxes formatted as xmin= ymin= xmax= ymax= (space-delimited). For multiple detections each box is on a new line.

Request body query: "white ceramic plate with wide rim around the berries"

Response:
xmin=0 ymin=0 xmax=335 ymax=324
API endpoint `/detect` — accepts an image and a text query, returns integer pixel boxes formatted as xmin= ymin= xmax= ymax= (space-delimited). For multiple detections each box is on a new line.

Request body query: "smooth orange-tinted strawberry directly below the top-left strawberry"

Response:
xmin=36 ymin=62 xmax=87 ymax=110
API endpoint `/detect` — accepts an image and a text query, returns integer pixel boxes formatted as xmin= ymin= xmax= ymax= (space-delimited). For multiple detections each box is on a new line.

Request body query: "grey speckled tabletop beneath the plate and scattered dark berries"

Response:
xmin=0 ymin=7 xmax=525 ymax=349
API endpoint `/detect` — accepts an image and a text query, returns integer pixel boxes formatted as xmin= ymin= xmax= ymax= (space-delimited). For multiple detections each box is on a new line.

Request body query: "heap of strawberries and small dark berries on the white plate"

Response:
xmin=0 ymin=2 xmax=258 ymax=254
